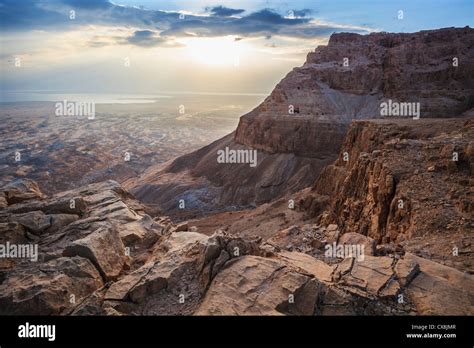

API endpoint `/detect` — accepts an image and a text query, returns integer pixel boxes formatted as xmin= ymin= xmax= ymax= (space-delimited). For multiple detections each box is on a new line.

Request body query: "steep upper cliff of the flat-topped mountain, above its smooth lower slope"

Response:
xmin=235 ymin=28 xmax=474 ymax=156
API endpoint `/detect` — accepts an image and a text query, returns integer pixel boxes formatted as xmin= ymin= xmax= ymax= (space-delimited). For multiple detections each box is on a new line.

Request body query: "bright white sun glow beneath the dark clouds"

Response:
xmin=181 ymin=36 xmax=248 ymax=67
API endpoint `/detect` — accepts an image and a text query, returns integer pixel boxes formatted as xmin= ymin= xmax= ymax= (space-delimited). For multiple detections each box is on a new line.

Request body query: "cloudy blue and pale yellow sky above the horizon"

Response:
xmin=0 ymin=0 xmax=474 ymax=94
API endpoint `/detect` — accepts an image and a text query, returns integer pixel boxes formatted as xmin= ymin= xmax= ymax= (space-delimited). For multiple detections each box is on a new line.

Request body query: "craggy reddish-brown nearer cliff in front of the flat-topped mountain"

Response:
xmin=303 ymin=118 xmax=474 ymax=268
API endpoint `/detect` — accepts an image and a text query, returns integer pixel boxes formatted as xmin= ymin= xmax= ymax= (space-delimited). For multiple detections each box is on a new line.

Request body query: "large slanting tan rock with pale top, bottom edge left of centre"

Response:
xmin=104 ymin=232 xmax=257 ymax=315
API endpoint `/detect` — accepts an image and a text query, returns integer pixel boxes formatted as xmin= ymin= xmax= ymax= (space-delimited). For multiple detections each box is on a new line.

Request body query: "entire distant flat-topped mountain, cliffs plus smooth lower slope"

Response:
xmin=125 ymin=28 xmax=474 ymax=214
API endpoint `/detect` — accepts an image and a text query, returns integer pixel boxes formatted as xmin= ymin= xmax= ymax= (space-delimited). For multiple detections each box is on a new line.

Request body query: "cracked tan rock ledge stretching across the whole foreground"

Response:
xmin=0 ymin=181 xmax=474 ymax=315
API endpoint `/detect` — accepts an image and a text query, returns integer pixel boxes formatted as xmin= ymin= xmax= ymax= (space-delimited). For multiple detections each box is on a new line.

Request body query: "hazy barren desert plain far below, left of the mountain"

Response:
xmin=0 ymin=95 xmax=261 ymax=193
